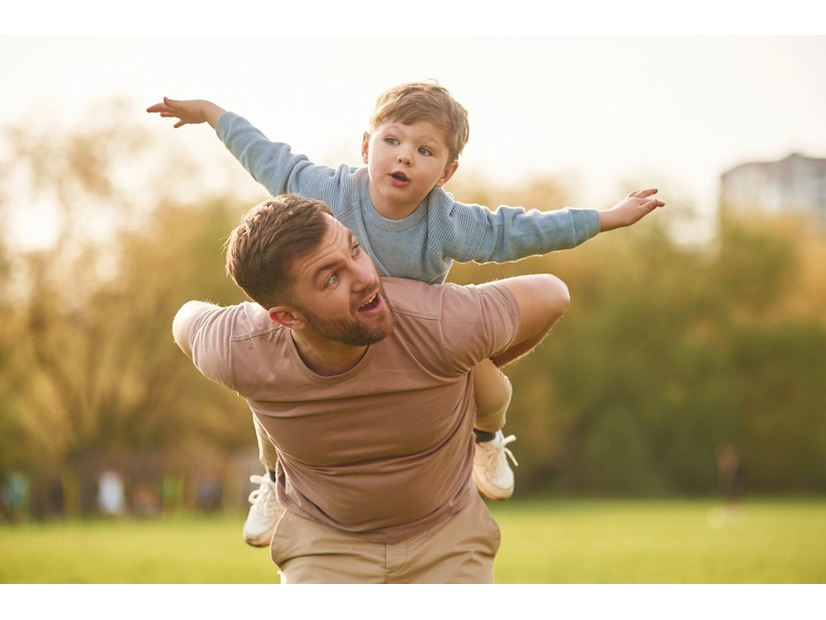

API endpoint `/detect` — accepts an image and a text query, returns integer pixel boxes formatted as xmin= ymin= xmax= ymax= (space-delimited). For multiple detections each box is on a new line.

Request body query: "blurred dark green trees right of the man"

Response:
xmin=453 ymin=186 xmax=826 ymax=495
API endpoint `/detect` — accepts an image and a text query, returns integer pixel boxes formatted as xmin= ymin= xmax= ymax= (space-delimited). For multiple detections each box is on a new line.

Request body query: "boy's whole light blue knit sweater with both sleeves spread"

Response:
xmin=215 ymin=112 xmax=600 ymax=283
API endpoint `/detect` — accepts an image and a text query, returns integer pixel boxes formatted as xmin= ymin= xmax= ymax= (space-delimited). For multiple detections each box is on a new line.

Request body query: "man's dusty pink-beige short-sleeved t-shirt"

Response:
xmin=189 ymin=278 xmax=519 ymax=543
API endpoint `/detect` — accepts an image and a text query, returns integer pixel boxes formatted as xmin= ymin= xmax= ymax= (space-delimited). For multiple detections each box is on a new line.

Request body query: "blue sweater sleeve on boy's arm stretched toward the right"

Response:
xmin=429 ymin=192 xmax=600 ymax=263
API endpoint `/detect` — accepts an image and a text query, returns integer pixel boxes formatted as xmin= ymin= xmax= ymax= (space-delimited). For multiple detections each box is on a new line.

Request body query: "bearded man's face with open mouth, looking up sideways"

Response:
xmin=290 ymin=217 xmax=393 ymax=346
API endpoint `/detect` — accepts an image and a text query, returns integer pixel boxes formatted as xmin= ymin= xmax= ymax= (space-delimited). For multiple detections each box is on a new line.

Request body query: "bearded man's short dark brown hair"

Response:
xmin=225 ymin=194 xmax=332 ymax=309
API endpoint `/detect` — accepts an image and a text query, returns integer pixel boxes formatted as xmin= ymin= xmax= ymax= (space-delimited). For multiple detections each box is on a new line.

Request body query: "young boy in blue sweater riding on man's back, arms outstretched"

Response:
xmin=147 ymin=82 xmax=664 ymax=546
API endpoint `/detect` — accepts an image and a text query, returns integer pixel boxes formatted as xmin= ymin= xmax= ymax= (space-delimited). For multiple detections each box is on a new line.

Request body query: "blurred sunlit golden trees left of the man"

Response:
xmin=0 ymin=101 xmax=253 ymax=482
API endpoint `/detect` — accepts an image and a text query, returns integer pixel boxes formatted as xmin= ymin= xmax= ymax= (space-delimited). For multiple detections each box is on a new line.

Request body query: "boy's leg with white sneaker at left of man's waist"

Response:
xmin=244 ymin=415 xmax=280 ymax=547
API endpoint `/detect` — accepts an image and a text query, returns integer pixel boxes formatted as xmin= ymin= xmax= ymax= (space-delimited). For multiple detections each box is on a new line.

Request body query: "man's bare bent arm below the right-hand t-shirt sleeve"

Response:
xmin=491 ymin=274 xmax=571 ymax=367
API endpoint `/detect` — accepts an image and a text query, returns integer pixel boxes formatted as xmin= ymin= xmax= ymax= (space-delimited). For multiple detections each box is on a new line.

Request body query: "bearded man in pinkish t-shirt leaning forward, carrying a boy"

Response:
xmin=173 ymin=195 xmax=570 ymax=583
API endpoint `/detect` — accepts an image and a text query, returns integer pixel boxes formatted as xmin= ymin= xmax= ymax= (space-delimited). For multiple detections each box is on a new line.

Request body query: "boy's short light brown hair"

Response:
xmin=369 ymin=82 xmax=470 ymax=162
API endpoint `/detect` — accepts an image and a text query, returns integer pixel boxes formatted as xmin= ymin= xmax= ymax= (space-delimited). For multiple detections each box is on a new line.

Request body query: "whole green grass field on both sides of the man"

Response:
xmin=0 ymin=499 xmax=826 ymax=584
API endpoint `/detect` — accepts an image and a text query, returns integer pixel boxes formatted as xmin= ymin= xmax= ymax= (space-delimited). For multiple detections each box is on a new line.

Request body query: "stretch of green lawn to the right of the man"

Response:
xmin=493 ymin=499 xmax=826 ymax=584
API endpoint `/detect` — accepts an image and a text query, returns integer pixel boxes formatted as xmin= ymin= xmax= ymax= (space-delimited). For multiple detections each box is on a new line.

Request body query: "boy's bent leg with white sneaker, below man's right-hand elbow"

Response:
xmin=471 ymin=360 xmax=516 ymax=500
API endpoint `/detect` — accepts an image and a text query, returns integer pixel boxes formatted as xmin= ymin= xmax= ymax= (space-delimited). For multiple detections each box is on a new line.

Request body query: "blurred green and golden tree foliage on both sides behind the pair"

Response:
xmin=0 ymin=99 xmax=826 ymax=506
